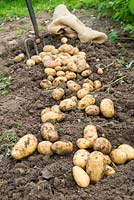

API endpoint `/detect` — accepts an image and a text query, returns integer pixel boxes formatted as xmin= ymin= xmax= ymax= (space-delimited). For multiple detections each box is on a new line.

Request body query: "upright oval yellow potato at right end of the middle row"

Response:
xmin=100 ymin=99 xmax=114 ymax=118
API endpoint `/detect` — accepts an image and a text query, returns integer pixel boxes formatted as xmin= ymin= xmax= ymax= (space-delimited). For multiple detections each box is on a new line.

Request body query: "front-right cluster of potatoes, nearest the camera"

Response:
xmin=72 ymin=125 xmax=134 ymax=187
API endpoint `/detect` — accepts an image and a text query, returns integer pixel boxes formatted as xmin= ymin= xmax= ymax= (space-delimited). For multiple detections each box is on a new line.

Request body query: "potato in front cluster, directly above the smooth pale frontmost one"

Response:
xmin=73 ymin=149 xmax=90 ymax=169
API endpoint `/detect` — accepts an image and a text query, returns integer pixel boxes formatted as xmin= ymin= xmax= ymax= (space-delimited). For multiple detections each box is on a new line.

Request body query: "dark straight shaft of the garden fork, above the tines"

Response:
xmin=26 ymin=0 xmax=39 ymax=38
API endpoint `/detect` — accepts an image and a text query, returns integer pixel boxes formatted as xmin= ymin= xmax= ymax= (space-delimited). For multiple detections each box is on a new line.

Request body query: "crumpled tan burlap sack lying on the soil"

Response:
xmin=48 ymin=4 xmax=107 ymax=43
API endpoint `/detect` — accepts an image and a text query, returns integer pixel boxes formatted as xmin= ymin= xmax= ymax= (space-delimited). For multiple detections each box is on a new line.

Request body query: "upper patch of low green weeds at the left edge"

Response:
xmin=0 ymin=71 xmax=11 ymax=95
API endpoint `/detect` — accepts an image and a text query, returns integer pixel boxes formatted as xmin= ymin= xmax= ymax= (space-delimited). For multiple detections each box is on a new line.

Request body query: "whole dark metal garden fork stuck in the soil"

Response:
xmin=24 ymin=0 xmax=45 ymax=59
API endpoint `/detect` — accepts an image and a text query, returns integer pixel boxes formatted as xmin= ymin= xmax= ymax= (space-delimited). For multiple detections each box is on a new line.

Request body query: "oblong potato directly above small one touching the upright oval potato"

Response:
xmin=78 ymin=94 xmax=95 ymax=110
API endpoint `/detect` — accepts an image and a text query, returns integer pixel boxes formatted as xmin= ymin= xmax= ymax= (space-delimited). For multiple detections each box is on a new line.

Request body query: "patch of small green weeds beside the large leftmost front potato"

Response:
xmin=0 ymin=129 xmax=17 ymax=156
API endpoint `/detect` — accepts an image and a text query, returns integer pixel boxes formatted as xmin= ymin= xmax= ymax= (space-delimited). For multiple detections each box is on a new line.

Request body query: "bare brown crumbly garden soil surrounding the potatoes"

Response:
xmin=0 ymin=10 xmax=134 ymax=200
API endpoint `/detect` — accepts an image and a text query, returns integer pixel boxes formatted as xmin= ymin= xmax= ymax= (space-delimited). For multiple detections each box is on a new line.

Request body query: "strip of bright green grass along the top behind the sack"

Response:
xmin=0 ymin=0 xmax=88 ymax=21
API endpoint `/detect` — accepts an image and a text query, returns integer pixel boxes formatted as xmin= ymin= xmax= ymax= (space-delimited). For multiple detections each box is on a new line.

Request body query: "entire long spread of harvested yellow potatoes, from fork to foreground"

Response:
xmin=11 ymin=38 xmax=134 ymax=187
